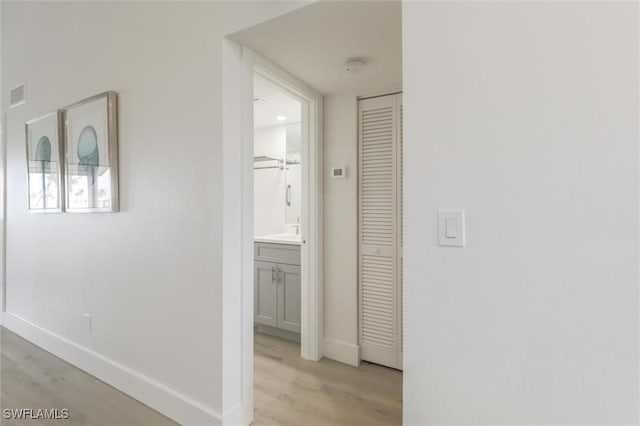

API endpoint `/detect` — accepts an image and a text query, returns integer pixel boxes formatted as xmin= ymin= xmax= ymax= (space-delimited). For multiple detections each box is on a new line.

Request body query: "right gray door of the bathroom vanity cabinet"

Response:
xmin=278 ymin=264 xmax=301 ymax=333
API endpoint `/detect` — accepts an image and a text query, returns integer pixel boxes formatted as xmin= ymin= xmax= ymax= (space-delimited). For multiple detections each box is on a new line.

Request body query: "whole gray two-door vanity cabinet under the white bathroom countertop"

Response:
xmin=254 ymin=242 xmax=301 ymax=333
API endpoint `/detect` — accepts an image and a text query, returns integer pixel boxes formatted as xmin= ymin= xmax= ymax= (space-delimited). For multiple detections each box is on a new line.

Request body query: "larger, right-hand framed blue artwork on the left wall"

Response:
xmin=63 ymin=92 xmax=119 ymax=213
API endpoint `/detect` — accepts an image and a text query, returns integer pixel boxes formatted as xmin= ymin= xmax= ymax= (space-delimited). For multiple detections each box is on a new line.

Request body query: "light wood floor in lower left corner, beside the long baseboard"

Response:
xmin=0 ymin=328 xmax=177 ymax=426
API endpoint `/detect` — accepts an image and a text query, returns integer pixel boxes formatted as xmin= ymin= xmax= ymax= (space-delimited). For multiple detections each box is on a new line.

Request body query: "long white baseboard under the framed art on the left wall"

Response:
xmin=2 ymin=312 xmax=222 ymax=426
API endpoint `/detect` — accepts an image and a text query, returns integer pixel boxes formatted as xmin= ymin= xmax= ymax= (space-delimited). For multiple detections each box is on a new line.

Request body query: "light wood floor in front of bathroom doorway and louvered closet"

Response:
xmin=253 ymin=333 xmax=402 ymax=426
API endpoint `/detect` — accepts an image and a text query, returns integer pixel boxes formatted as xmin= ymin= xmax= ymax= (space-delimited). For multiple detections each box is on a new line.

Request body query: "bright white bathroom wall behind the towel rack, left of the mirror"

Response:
xmin=253 ymin=126 xmax=287 ymax=236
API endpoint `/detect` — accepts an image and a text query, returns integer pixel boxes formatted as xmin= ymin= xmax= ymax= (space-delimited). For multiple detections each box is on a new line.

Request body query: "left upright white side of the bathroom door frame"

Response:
xmin=217 ymin=38 xmax=253 ymax=425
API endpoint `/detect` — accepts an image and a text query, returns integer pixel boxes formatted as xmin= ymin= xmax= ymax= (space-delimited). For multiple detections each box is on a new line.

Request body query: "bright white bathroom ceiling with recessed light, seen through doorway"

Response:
xmin=253 ymin=74 xmax=302 ymax=128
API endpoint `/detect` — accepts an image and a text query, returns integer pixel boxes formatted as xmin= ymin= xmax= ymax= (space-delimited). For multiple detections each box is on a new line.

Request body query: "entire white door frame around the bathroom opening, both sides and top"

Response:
xmin=221 ymin=38 xmax=323 ymax=425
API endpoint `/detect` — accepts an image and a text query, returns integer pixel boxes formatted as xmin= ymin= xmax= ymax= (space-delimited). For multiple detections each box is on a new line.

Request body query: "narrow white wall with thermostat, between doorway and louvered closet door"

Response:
xmin=323 ymin=94 xmax=359 ymax=365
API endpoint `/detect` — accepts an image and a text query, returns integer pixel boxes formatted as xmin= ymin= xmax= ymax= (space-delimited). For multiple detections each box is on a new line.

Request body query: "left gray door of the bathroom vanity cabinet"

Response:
xmin=253 ymin=262 xmax=278 ymax=327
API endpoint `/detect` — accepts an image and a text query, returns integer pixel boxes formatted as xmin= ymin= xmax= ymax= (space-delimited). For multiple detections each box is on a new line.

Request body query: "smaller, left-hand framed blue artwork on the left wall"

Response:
xmin=25 ymin=112 xmax=63 ymax=212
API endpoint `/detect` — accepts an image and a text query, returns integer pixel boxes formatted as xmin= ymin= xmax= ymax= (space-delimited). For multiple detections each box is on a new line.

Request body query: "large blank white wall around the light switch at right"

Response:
xmin=403 ymin=2 xmax=640 ymax=425
